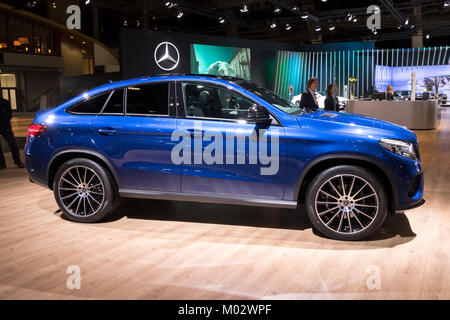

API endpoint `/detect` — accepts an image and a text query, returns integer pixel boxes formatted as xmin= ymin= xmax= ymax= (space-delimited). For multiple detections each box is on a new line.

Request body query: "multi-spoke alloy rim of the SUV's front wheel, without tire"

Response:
xmin=315 ymin=174 xmax=380 ymax=234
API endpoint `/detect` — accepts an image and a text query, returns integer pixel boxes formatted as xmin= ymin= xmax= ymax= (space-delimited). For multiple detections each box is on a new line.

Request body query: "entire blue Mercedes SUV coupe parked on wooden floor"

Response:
xmin=25 ymin=75 xmax=424 ymax=240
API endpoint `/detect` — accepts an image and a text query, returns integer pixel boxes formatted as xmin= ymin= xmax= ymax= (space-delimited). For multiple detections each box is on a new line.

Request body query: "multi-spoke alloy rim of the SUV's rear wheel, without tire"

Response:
xmin=58 ymin=166 xmax=105 ymax=218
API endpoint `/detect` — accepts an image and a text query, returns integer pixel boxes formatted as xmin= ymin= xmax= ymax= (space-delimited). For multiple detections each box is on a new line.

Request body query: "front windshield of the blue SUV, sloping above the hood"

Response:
xmin=236 ymin=81 xmax=314 ymax=115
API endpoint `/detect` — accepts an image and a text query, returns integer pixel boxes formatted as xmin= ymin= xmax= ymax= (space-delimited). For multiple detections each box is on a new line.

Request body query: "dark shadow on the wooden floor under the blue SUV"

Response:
xmin=93 ymin=198 xmax=416 ymax=247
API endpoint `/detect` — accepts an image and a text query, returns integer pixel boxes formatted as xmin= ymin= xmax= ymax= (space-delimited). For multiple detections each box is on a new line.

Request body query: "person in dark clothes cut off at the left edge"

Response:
xmin=0 ymin=97 xmax=25 ymax=169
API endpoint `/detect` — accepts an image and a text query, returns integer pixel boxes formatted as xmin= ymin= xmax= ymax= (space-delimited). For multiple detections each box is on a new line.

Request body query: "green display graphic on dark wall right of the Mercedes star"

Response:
xmin=191 ymin=44 xmax=251 ymax=80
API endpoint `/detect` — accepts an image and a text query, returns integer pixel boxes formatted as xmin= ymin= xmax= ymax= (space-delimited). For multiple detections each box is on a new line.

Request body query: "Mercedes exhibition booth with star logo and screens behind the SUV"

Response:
xmin=121 ymin=29 xmax=450 ymax=129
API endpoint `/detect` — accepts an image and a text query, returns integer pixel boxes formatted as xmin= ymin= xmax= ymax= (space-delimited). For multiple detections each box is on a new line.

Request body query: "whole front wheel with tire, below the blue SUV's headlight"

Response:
xmin=305 ymin=165 xmax=388 ymax=240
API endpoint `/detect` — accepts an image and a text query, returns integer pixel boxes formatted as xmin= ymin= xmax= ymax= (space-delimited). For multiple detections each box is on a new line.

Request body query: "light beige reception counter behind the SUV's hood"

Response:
xmin=347 ymin=100 xmax=440 ymax=129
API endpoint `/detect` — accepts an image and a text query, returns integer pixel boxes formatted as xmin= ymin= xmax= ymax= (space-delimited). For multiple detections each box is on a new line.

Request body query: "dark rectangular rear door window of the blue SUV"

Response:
xmin=127 ymin=82 xmax=169 ymax=116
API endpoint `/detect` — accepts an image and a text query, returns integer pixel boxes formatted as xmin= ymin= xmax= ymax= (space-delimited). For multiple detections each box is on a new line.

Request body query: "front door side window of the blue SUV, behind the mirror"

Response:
xmin=183 ymin=83 xmax=255 ymax=120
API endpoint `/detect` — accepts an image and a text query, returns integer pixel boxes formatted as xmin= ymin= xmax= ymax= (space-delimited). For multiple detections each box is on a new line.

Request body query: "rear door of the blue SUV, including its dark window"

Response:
xmin=91 ymin=81 xmax=180 ymax=192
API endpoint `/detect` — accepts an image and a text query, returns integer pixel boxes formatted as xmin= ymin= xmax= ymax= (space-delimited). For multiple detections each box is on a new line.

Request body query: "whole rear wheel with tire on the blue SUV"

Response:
xmin=53 ymin=158 xmax=118 ymax=223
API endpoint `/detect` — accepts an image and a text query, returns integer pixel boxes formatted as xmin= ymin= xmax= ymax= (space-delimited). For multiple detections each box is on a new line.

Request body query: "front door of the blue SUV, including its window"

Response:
xmin=176 ymin=81 xmax=287 ymax=199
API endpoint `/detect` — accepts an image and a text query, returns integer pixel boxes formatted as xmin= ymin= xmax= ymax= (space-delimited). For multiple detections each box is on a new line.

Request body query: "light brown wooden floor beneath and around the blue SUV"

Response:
xmin=0 ymin=109 xmax=450 ymax=299
